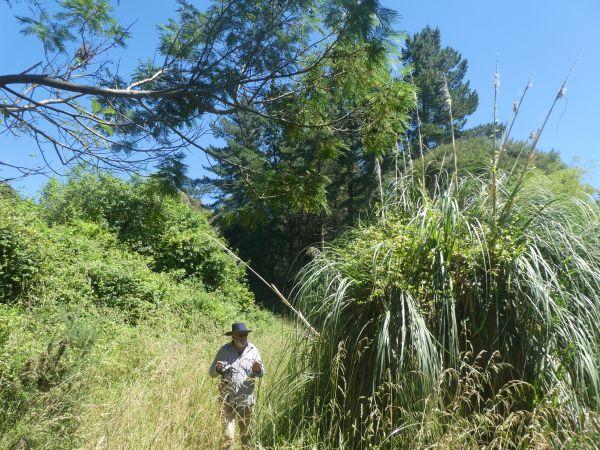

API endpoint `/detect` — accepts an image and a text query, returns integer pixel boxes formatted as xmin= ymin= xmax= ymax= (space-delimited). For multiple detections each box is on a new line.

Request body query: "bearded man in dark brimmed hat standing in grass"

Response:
xmin=209 ymin=323 xmax=264 ymax=450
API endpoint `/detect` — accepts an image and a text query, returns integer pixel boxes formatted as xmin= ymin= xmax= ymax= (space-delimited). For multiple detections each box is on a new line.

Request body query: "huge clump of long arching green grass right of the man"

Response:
xmin=263 ymin=171 xmax=600 ymax=448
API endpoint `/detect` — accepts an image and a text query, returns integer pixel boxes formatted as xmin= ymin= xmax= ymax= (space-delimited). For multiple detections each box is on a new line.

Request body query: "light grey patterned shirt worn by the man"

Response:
xmin=209 ymin=342 xmax=264 ymax=407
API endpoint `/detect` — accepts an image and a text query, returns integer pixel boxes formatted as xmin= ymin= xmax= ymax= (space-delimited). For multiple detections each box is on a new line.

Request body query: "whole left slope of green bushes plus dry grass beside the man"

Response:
xmin=0 ymin=172 xmax=283 ymax=449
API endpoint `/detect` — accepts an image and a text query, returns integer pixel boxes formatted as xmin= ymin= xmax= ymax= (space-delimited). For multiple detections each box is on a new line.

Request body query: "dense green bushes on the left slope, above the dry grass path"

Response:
xmin=0 ymin=173 xmax=264 ymax=448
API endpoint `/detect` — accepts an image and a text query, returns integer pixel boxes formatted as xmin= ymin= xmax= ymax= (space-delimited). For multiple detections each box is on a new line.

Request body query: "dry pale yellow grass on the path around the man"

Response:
xmin=76 ymin=323 xmax=289 ymax=449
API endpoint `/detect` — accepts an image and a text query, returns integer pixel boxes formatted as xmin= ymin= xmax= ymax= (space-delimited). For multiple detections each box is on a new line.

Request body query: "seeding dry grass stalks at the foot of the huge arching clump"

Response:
xmin=258 ymin=349 xmax=600 ymax=450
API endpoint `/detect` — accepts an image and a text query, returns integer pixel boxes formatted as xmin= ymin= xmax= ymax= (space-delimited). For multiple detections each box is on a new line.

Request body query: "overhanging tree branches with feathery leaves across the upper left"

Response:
xmin=0 ymin=0 xmax=404 ymax=179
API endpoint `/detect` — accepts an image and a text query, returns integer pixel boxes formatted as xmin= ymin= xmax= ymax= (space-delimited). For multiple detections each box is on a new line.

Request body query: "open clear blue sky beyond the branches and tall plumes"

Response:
xmin=0 ymin=0 xmax=600 ymax=195
